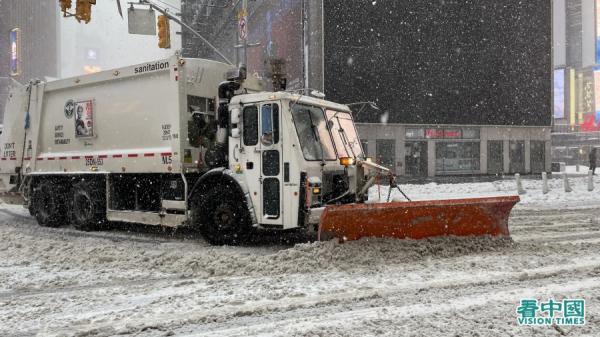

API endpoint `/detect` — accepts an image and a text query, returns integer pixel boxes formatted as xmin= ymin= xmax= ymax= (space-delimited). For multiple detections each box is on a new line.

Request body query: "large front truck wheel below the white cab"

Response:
xmin=192 ymin=189 xmax=252 ymax=245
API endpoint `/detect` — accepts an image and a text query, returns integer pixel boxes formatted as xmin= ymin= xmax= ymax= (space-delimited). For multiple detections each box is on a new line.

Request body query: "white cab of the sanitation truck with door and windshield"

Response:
xmin=228 ymin=92 xmax=365 ymax=234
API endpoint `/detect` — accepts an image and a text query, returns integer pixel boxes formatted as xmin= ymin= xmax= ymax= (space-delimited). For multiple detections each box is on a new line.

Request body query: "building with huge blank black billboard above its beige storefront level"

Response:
xmin=324 ymin=0 xmax=552 ymax=177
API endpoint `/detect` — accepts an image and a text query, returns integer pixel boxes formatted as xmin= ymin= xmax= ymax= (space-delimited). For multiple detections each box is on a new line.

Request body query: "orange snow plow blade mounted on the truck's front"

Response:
xmin=318 ymin=196 xmax=520 ymax=241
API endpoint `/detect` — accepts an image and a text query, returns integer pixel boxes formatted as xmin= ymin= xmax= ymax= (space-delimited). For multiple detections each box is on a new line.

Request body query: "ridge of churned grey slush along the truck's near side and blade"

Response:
xmin=0 ymin=217 xmax=514 ymax=283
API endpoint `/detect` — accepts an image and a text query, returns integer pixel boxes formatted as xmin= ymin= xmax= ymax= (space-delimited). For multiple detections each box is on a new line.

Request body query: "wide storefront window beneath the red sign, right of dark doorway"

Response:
xmin=435 ymin=142 xmax=480 ymax=174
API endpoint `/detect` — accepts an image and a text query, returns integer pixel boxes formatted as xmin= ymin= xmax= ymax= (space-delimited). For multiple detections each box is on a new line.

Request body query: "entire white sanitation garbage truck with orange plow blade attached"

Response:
xmin=0 ymin=55 xmax=518 ymax=244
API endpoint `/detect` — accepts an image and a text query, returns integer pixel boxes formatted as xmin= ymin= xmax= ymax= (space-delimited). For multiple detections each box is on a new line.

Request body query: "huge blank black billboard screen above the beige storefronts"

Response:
xmin=324 ymin=0 xmax=552 ymax=125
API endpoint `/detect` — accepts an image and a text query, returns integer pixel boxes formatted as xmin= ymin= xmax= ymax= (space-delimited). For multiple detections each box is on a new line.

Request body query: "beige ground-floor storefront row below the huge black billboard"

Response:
xmin=358 ymin=123 xmax=551 ymax=177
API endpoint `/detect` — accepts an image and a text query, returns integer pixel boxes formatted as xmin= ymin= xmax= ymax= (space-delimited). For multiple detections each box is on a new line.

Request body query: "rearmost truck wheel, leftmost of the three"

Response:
xmin=29 ymin=181 xmax=67 ymax=227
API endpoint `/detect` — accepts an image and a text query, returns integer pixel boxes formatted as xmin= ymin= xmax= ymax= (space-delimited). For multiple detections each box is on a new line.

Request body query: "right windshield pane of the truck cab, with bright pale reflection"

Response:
xmin=326 ymin=110 xmax=363 ymax=158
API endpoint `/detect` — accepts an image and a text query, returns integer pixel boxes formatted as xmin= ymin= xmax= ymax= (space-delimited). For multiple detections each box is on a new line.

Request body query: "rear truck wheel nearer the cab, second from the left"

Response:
xmin=72 ymin=181 xmax=106 ymax=231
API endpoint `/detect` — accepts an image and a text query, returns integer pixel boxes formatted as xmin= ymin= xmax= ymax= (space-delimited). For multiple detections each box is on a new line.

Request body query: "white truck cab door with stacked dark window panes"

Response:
xmin=243 ymin=102 xmax=283 ymax=225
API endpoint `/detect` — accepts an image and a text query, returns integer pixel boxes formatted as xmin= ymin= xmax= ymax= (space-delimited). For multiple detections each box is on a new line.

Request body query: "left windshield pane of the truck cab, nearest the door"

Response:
xmin=292 ymin=104 xmax=336 ymax=160
